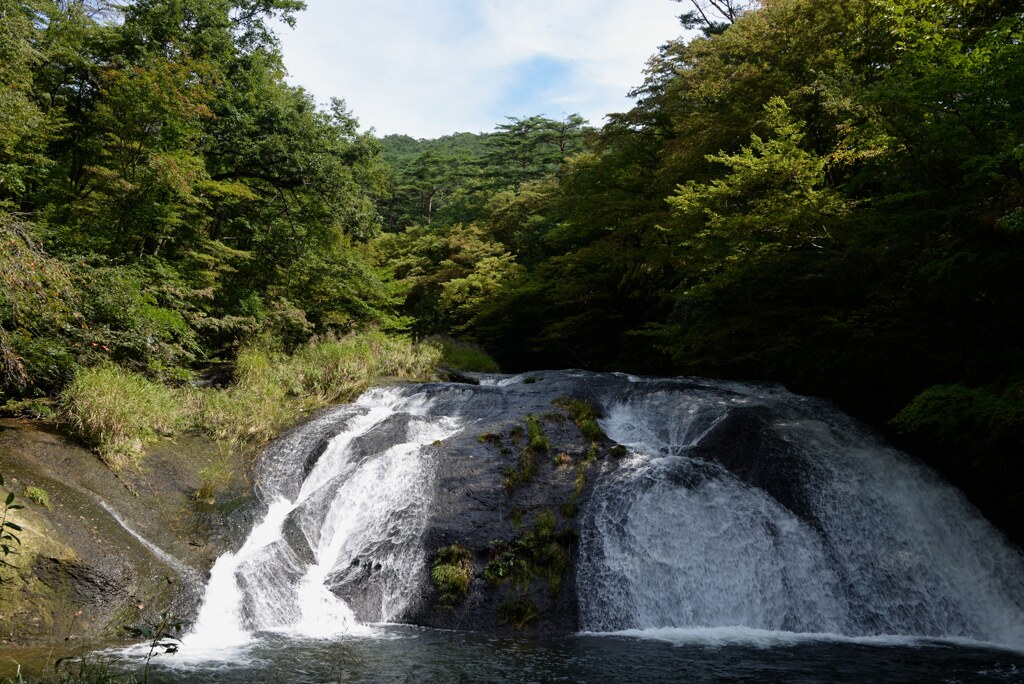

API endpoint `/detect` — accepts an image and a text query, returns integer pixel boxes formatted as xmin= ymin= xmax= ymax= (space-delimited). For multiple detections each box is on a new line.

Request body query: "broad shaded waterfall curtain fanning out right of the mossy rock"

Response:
xmin=578 ymin=381 xmax=1024 ymax=648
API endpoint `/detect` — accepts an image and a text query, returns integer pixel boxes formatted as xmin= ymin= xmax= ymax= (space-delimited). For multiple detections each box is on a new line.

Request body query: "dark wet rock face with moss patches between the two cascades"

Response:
xmin=409 ymin=404 xmax=610 ymax=633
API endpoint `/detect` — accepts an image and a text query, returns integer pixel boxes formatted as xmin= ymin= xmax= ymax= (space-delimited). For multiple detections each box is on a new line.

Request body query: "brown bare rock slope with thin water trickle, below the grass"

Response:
xmin=0 ymin=420 xmax=249 ymax=645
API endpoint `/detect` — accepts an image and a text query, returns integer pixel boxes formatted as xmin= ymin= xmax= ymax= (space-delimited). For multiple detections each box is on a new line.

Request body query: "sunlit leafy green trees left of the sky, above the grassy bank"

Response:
xmin=0 ymin=0 xmax=402 ymax=399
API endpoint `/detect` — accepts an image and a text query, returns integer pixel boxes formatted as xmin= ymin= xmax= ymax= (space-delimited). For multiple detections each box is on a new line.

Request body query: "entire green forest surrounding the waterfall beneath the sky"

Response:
xmin=0 ymin=0 xmax=1024 ymax=540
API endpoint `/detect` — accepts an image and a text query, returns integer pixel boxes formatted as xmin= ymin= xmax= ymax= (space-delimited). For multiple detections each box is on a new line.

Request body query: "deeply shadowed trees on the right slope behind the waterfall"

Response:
xmin=380 ymin=0 xmax=1024 ymax=531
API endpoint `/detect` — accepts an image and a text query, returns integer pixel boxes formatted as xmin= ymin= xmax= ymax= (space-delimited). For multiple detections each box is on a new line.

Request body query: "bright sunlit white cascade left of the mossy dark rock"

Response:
xmin=181 ymin=389 xmax=459 ymax=657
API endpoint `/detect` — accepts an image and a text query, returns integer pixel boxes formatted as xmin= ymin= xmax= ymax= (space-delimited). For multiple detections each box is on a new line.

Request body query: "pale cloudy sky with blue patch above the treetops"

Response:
xmin=280 ymin=0 xmax=684 ymax=138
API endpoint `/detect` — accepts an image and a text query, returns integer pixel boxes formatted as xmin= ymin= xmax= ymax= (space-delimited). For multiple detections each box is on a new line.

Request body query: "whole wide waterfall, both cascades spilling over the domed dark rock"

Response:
xmin=182 ymin=372 xmax=1024 ymax=651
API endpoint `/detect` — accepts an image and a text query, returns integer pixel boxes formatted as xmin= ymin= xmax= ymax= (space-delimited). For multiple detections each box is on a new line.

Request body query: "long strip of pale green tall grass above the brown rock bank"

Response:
xmin=61 ymin=332 xmax=441 ymax=469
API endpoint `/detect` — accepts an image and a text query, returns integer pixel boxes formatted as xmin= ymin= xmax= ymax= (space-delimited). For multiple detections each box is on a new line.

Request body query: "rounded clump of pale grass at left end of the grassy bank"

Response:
xmin=61 ymin=364 xmax=186 ymax=470
